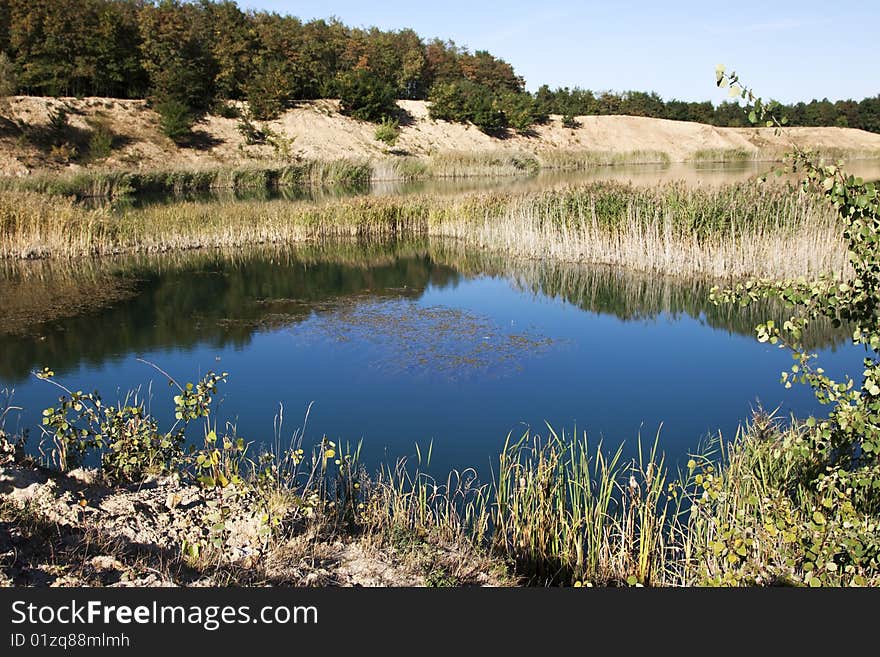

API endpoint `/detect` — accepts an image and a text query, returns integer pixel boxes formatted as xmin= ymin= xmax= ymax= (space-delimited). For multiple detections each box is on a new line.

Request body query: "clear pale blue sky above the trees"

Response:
xmin=238 ymin=0 xmax=880 ymax=102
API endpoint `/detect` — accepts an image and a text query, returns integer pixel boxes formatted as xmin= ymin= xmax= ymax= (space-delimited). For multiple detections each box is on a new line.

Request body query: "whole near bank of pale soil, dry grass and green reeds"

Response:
xmin=0 ymin=413 xmax=880 ymax=587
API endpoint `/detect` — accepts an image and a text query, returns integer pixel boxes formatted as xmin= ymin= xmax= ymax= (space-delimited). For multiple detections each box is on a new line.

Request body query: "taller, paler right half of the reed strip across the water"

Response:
xmin=438 ymin=185 xmax=849 ymax=278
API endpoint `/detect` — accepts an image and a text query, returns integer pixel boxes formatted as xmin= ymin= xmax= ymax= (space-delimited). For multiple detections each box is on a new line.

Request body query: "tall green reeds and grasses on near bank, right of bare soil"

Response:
xmin=358 ymin=411 xmax=880 ymax=586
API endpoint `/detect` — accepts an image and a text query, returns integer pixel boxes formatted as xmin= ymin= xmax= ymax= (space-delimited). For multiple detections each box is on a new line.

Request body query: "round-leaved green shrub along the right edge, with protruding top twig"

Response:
xmin=713 ymin=67 xmax=880 ymax=586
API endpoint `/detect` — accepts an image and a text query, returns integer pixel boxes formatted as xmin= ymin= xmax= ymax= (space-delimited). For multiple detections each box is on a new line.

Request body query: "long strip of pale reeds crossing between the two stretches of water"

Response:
xmin=0 ymin=184 xmax=848 ymax=278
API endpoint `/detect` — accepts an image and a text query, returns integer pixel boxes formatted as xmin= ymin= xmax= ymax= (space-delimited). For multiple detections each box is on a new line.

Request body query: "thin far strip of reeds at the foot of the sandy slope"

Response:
xmin=0 ymin=149 xmax=880 ymax=199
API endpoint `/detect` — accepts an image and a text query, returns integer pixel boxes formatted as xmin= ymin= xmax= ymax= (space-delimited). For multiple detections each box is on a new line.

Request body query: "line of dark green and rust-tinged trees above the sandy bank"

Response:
xmin=0 ymin=0 xmax=880 ymax=134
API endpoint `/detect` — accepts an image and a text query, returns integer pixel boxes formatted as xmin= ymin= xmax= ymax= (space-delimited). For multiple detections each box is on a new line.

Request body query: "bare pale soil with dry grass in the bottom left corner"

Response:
xmin=0 ymin=438 xmax=513 ymax=587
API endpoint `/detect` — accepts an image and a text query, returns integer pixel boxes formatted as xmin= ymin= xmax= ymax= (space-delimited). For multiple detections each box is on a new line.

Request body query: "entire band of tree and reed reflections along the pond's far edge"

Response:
xmin=0 ymin=242 xmax=846 ymax=381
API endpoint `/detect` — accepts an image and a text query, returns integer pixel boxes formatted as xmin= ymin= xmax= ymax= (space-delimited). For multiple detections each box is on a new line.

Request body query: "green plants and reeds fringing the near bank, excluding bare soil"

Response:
xmin=24 ymin=358 xmax=880 ymax=586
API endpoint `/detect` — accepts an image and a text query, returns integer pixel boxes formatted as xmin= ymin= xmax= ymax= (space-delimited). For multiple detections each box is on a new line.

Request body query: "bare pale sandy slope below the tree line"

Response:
xmin=0 ymin=96 xmax=880 ymax=175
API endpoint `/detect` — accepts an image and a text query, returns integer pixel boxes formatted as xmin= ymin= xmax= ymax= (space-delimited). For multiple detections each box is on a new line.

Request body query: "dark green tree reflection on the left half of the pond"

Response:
xmin=0 ymin=243 xmax=457 ymax=380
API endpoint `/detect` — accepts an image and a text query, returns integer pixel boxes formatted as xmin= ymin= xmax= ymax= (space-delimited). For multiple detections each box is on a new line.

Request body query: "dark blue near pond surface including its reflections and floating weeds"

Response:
xmin=0 ymin=244 xmax=862 ymax=472
